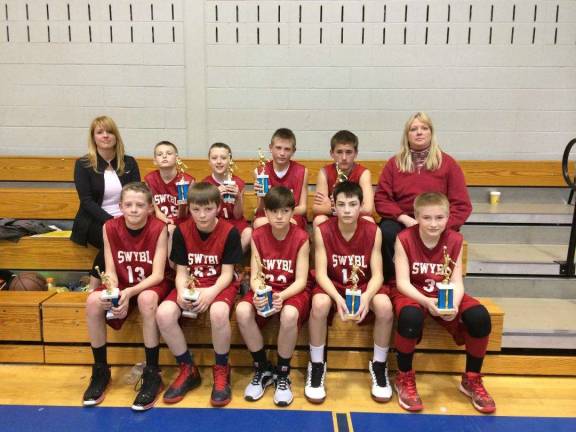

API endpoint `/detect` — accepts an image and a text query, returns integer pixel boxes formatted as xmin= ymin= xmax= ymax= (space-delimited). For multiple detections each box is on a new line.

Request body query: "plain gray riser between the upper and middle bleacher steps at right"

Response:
xmin=461 ymin=225 xmax=570 ymax=244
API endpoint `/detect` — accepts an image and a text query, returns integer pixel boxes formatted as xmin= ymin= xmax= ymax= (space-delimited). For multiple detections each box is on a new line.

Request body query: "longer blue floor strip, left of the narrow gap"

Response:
xmin=0 ymin=405 xmax=334 ymax=432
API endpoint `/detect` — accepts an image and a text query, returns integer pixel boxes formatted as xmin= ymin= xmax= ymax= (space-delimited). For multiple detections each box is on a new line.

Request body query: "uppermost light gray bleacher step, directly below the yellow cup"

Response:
xmin=467 ymin=202 xmax=574 ymax=224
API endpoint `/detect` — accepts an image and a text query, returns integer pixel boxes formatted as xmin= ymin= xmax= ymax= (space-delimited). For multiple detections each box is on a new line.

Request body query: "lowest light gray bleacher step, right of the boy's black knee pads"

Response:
xmin=493 ymin=297 xmax=576 ymax=349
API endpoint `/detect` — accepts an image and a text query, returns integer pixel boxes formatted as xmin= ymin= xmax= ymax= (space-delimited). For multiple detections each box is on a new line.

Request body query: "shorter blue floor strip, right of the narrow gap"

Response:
xmin=350 ymin=413 xmax=576 ymax=432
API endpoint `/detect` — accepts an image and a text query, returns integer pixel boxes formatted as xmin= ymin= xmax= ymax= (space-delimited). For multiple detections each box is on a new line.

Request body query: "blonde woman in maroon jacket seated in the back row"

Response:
xmin=374 ymin=112 xmax=472 ymax=281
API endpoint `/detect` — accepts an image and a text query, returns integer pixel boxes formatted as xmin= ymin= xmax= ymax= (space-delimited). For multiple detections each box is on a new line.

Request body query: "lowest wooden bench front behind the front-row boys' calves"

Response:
xmin=42 ymin=293 xmax=503 ymax=351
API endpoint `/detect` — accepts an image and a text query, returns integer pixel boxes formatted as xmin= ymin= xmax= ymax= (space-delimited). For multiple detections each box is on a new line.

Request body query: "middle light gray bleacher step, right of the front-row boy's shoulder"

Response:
xmin=467 ymin=243 xmax=568 ymax=276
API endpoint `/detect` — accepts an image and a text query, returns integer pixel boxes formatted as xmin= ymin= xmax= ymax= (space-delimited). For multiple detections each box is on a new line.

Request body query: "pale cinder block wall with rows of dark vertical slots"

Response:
xmin=0 ymin=0 xmax=576 ymax=159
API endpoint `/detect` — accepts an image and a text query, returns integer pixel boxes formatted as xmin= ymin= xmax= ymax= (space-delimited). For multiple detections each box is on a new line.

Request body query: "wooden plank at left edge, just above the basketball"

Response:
xmin=0 ymin=237 xmax=97 ymax=271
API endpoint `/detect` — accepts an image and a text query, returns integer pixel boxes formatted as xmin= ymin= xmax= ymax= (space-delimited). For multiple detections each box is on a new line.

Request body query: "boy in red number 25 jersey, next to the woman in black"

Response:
xmin=144 ymin=141 xmax=196 ymax=233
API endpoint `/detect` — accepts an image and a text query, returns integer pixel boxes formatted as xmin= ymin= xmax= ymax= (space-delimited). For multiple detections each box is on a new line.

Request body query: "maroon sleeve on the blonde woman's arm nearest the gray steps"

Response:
xmin=442 ymin=154 xmax=472 ymax=230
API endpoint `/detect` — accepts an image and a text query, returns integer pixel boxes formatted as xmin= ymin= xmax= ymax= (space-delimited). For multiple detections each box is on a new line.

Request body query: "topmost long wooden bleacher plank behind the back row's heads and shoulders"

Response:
xmin=0 ymin=155 xmax=564 ymax=187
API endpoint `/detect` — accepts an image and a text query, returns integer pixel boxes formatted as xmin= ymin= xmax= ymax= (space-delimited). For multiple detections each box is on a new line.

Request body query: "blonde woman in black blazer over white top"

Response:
xmin=70 ymin=116 xmax=140 ymax=289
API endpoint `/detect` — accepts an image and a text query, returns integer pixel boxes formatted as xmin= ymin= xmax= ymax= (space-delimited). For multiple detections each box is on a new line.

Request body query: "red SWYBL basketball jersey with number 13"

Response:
xmin=104 ymin=216 xmax=168 ymax=289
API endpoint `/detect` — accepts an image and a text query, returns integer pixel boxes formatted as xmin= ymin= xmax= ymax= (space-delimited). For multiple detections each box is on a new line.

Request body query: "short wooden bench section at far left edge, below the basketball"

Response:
xmin=0 ymin=291 xmax=54 ymax=341
